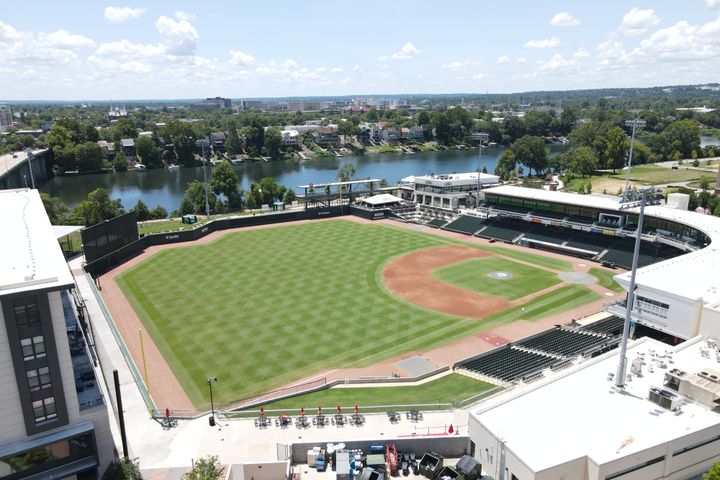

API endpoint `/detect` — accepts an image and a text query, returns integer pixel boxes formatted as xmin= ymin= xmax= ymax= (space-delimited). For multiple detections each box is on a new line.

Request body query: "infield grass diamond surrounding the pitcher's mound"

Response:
xmin=432 ymin=257 xmax=560 ymax=300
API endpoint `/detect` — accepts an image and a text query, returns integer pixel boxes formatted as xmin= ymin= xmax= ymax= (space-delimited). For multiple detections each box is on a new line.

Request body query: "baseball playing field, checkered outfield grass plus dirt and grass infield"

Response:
xmin=116 ymin=220 xmax=599 ymax=407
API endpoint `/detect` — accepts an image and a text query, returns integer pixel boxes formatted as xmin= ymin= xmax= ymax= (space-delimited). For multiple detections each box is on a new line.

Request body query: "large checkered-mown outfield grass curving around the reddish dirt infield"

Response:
xmin=117 ymin=220 xmax=588 ymax=407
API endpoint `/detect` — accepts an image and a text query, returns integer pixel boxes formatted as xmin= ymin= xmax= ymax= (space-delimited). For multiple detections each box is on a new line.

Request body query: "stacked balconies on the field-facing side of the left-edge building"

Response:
xmin=61 ymin=290 xmax=105 ymax=411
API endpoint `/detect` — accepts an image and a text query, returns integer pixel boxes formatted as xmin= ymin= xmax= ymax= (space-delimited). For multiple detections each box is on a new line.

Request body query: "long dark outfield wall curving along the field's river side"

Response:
xmin=85 ymin=205 xmax=351 ymax=276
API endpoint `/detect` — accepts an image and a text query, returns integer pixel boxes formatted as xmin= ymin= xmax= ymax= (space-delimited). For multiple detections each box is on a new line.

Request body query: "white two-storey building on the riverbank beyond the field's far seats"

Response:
xmin=400 ymin=172 xmax=500 ymax=210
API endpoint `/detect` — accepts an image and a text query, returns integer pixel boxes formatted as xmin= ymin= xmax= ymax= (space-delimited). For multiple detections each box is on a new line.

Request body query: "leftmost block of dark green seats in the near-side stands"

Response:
xmin=457 ymin=347 xmax=557 ymax=382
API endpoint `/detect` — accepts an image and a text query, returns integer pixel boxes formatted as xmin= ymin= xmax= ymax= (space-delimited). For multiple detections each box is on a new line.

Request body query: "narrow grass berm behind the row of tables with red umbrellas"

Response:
xmin=231 ymin=373 xmax=495 ymax=415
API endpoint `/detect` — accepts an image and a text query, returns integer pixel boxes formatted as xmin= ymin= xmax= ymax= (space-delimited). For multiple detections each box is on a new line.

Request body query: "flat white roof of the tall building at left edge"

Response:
xmin=0 ymin=189 xmax=73 ymax=296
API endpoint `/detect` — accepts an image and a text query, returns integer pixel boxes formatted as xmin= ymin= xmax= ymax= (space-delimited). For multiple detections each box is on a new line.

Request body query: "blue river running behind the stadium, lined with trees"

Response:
xmin=40 ymin=145 xmax=580 ymax=212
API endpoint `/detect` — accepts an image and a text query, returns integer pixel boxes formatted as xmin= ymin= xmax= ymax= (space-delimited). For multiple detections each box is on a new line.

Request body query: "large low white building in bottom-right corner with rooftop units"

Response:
xmin=469 ymin=337 xmax=720 ymax=480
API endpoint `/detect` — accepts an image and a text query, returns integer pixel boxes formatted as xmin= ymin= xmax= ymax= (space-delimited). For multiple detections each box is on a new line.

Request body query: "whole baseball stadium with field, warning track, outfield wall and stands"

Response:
xmin=84 ymin=174 xmax=706 ymax=415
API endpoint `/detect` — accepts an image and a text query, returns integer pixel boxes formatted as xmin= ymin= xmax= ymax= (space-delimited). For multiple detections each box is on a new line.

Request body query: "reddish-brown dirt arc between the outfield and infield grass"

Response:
xmin=383 ymin=246 xmax=511 ymax=319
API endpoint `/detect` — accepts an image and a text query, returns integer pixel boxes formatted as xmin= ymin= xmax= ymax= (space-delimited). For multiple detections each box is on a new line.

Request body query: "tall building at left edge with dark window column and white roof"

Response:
xmin=0 ymin=189 xmax=115 ymax=480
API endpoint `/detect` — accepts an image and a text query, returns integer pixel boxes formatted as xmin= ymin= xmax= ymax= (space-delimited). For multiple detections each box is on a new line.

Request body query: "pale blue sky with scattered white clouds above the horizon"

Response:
xmin=0 ymin=0 xmax=720 ymax=100
